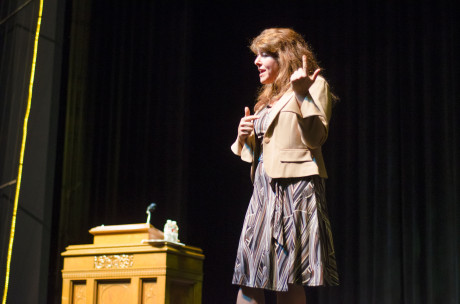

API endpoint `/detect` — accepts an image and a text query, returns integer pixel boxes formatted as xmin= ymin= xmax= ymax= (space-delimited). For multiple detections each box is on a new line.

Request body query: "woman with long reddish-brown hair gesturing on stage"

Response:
xmin=232 ymin=28 xmax=338 ymax=304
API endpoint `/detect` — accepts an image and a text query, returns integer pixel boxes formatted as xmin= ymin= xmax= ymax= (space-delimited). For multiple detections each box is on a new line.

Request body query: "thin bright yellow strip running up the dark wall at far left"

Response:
xmin=2 ymin=0 xmax=43 ymax=304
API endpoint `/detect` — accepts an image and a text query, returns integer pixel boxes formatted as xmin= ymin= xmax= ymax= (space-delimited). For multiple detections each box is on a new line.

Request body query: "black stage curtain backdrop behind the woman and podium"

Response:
xmin=50 ymin=1 xmax=460 ymax=304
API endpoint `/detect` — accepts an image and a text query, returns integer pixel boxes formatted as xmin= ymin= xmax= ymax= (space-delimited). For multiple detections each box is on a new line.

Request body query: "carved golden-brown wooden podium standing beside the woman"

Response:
xmin=62 ymin=224 xmax=204 ymax=304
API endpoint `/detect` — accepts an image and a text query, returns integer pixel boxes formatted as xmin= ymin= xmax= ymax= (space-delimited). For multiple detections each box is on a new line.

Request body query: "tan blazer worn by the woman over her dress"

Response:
xmin=231 ymin=76 xmax=332 ymax=179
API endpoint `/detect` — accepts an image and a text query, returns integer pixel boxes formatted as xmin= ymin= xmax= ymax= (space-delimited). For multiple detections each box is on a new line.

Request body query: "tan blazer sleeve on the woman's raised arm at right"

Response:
xmin=299 ymin=76 xmax=332 ymax=149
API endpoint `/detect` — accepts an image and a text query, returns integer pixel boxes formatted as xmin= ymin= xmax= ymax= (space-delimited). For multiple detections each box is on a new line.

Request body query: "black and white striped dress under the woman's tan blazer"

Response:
xmin=233 ymin=107 xmax=339 ymax=291
